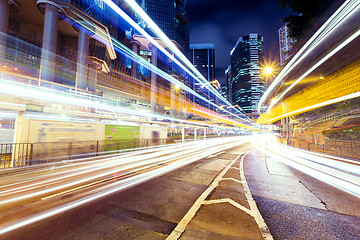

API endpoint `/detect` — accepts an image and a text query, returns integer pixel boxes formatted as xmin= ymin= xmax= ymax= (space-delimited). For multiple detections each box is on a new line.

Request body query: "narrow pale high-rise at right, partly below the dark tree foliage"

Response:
xmin=278 ymin=23 xmax=295 ymax=66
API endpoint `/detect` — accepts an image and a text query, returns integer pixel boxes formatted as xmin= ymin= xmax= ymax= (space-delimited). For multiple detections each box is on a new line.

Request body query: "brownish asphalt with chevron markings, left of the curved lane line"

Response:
xmin=1 ymin=140 xmax=266 ymax=240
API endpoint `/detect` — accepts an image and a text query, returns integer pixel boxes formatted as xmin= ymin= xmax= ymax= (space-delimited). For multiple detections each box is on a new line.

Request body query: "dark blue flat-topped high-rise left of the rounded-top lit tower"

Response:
xmin=190 ymin=44 xmax=215 ymax=109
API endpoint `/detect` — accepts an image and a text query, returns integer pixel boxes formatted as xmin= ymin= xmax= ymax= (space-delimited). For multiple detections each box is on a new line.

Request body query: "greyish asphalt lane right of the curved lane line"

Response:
xmin=245 ymin=150 xmax=360 ymax=240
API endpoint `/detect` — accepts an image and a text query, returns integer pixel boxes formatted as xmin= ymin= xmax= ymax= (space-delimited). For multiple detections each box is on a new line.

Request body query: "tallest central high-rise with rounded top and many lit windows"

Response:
xmin=230 ymin=33 xmax=265 ymax=117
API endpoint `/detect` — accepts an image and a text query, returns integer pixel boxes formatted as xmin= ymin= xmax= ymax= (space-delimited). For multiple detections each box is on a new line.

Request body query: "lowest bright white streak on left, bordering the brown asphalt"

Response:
xmin=0 ymin=137 xmax=248 ymax=234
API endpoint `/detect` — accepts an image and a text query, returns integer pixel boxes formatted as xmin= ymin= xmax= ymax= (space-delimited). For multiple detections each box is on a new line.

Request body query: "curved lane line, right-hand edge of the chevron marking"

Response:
xmin=240 ymin=152 xmax=273 ymax=240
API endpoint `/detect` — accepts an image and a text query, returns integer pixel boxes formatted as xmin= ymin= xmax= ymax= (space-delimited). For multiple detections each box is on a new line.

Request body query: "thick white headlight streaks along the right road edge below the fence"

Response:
xmin=253 ymin=135 xmax=360 ymax=197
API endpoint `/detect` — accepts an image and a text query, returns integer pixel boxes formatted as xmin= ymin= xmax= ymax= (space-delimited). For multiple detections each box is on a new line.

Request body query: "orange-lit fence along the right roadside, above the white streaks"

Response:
xmin=280 ymin=138 xmax=360 ymax=159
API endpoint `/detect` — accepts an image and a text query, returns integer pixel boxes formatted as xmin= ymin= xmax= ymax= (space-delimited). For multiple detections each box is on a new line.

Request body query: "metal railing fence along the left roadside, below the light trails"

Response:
xmin=0 ymin=138 xmax=174 ymax=168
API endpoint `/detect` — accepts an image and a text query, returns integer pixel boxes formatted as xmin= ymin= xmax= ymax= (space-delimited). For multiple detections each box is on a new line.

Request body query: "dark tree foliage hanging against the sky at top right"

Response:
xmin=278 ymin=0 xmax=334 ymax=40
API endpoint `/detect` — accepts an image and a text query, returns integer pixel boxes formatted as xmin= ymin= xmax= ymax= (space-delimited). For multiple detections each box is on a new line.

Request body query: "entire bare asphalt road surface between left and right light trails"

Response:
xmin=0 ymin=138 xmax=360 ymax=240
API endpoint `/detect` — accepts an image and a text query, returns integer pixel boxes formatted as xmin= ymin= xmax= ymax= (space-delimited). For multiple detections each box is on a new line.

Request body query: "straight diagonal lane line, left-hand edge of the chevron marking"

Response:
xmin=166 ymin=153 xmax=240 ymax=240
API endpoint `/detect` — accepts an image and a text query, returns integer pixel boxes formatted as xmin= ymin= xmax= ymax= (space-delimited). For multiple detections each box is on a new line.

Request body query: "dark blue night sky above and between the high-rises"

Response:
xmin=186 ymin=0 xmax=291 ymax=83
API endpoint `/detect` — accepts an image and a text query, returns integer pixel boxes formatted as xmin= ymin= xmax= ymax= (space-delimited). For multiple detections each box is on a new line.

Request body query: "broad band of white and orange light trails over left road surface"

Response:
xmin=0 ymin=137 xmax=249 ymax=234
